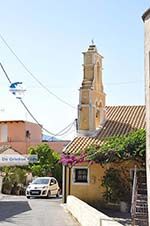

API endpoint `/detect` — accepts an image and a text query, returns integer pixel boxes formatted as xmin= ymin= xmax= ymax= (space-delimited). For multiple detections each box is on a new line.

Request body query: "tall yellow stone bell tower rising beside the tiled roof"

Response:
xmin=78 ymin=43 xmax=105 ymax=136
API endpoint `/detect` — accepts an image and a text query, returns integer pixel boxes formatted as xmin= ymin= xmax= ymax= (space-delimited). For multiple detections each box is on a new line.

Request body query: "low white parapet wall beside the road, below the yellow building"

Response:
xmin=67 ymin=195 xmax=122 ymax=226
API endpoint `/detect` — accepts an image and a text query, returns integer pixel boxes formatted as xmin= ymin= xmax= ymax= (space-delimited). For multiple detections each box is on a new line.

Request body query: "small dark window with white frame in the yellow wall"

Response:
xmin=73 ymin=167 xmax=88 ymax=183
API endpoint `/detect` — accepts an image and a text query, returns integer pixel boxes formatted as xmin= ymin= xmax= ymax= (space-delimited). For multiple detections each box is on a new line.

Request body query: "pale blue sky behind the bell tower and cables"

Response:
xmin=0 ymin=0 xmax=150 ymax=139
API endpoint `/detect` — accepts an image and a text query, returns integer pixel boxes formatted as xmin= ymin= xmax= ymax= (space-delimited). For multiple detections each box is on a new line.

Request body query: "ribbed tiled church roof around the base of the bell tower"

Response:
xmin=63 ymin=106 xmax=146 ymax=153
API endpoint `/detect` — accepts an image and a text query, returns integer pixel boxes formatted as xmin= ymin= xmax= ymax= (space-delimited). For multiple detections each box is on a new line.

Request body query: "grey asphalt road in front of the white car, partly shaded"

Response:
xmin=0 ymin=196 xmax=79 ymax=226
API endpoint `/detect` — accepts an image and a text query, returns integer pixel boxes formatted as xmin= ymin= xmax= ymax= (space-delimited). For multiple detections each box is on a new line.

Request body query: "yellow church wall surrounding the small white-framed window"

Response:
xmin=67 ymin=161 xmax=141 ymax=202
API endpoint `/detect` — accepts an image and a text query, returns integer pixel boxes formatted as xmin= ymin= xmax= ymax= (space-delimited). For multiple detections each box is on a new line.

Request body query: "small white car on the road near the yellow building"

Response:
xmin=26 ymin=177 xmax=60 ymax=199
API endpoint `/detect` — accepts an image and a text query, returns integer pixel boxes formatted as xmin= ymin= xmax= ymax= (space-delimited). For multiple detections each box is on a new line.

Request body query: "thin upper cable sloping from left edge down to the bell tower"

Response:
xmin=0 ymin=34 xmax=76 ymax=109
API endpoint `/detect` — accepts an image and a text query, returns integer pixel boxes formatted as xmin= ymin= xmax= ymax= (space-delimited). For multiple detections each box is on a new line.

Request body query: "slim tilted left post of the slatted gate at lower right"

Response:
xmin=131 ymin=166 xmax=137 ymax=226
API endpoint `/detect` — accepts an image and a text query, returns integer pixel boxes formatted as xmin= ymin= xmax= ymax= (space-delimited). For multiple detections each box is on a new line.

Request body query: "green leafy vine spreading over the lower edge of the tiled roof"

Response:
xmin=86 ymin=129 xmax=146 ymax=164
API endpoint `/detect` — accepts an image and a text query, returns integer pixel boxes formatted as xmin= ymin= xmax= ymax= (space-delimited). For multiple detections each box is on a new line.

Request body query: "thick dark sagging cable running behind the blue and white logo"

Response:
xmin=0 ymin=62 xmax=74 ymax=136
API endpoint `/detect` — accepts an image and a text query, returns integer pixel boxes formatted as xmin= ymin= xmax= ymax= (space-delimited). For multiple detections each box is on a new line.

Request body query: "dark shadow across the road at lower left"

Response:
xmin=0 ymin=201 xmax=31 ymax=221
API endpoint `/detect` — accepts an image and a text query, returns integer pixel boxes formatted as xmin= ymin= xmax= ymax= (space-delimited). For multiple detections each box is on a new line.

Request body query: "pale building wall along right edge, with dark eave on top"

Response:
xmin=142 ymin=8 xmax=150 ymax=225
